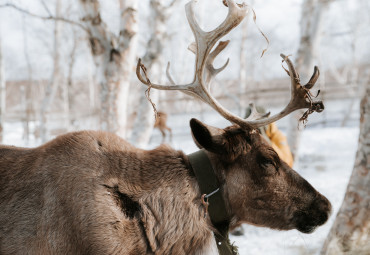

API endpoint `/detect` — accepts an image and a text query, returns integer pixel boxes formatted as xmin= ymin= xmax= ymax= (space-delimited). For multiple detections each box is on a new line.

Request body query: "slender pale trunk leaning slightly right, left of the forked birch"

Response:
xmin=40 ymin=0 xmax=62 ymax=143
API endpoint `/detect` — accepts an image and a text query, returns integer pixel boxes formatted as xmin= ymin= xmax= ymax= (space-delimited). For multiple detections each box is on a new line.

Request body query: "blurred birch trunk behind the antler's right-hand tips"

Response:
xmin=287 ymin=0 xmax=331 ymax=160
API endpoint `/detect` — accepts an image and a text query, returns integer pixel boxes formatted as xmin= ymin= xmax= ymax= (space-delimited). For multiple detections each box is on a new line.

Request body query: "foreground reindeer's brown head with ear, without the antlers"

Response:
xmin=190 ymin=119 xmax=331 ymax=233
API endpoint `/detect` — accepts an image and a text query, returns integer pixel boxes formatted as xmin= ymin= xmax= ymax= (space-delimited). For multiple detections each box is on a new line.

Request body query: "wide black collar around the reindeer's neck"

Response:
xmin=188 ymin=150 xmax=237 ymax=255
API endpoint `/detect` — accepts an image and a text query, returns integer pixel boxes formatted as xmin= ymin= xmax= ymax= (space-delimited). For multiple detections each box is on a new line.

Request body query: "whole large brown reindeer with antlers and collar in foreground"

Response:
xmin=0 ymin=0 xmax=331 ymax=255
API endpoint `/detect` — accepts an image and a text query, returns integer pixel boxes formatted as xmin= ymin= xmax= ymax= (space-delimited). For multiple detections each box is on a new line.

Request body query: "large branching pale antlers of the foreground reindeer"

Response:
xmin=136 ymin=0 xmax=324 ymax=129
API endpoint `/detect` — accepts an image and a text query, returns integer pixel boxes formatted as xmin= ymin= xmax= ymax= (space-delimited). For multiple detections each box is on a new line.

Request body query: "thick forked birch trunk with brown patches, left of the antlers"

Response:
xmin=79 ymin=0 xmax=137 ymax=137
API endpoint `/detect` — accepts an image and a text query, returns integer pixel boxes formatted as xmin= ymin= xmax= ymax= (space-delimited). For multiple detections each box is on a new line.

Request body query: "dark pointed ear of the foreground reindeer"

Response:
xmin=190 ymin=119 xmax=226 ymax=154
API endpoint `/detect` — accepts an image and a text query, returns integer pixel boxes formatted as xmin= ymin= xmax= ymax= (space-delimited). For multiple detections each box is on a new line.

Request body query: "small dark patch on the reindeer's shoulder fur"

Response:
xmin=103 ymin=185 xmax=141 ymax=219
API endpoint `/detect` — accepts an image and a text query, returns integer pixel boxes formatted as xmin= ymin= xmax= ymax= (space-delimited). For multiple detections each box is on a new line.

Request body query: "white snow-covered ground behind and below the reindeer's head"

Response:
xmin=4 ymin=99 xmax=359 ymax=255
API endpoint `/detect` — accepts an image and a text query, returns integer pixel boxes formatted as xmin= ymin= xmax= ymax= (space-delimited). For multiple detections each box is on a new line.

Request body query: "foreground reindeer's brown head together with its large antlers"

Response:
xmin=136 ymin=0 xmax=331 ymax=233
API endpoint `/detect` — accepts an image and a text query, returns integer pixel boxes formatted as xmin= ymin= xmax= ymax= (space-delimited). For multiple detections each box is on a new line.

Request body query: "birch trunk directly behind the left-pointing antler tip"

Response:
xmin=130 ymin=0 xmax=176 ymax=147
